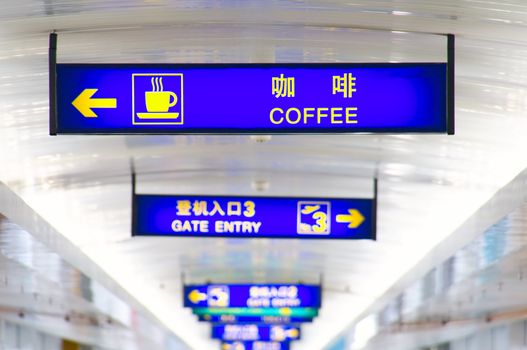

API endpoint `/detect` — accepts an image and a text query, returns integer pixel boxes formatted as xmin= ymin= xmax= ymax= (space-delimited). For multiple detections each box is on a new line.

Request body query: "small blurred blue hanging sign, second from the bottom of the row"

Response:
xmin=212 ymin=324 xmax=300 ymax=342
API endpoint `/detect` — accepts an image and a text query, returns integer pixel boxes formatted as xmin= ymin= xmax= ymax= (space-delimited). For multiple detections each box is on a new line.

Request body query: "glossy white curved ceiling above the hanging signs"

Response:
xmin=0 ymin=0 xmax=527 ymax=350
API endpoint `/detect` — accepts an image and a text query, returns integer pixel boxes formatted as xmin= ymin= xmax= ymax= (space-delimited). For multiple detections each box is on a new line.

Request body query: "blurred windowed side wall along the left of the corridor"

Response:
xmin=0 ymin=185 xmax=184 ymax=350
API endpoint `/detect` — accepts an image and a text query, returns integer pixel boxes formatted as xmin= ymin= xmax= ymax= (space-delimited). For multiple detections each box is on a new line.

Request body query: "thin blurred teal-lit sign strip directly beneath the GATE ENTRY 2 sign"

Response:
xmin=192 ymin=307 xmax=318 ymax=318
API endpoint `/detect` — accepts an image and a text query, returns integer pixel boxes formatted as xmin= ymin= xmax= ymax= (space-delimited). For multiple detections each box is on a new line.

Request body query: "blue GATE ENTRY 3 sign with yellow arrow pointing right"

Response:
xmin=132 ymin=195 xmax=375 ymax=239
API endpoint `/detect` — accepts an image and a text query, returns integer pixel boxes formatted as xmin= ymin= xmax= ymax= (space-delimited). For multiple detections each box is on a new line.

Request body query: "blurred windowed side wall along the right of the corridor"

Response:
xmin=353 ymin=180 xmax=527 ymax=349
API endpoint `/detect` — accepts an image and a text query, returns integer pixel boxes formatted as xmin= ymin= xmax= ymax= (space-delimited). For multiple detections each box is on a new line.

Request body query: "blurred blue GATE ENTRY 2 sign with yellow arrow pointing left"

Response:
xmin=184 ymin=284 xmax=321 ymax=308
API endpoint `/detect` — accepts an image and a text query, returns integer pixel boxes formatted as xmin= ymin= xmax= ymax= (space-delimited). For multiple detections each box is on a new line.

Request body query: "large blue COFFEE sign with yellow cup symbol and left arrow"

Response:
xmin=52 ymin=63 xmax=448 ymax=134
